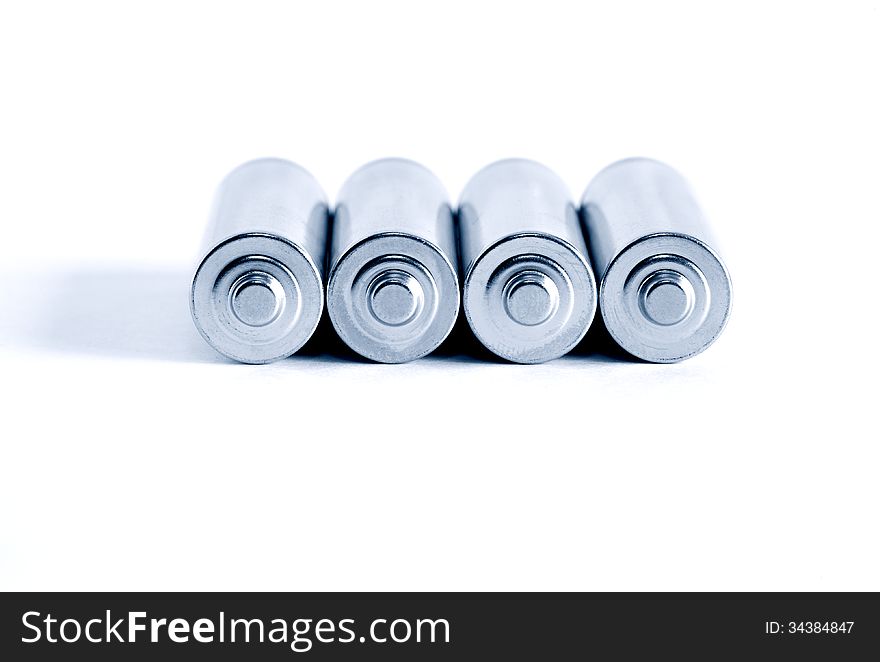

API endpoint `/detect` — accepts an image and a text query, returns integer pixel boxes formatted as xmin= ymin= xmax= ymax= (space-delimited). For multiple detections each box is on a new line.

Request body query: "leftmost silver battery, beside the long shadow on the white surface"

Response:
xmin=190 ymin=159 xmax=329 ymax=363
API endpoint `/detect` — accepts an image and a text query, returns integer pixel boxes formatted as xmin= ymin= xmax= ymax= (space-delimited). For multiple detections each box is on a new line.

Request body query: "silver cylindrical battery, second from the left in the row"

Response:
xmin=327 ymin=159 xmax=459 ymax=363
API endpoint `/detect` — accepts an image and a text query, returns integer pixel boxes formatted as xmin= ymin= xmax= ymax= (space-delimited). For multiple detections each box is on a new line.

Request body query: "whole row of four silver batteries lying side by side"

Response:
xmin=190 ymin=158 xmax=730 ymax=363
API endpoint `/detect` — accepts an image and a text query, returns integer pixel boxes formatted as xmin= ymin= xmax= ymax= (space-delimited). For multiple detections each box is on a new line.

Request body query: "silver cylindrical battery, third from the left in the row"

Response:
xmin=459 ymin=159 xmax=596 ymax=363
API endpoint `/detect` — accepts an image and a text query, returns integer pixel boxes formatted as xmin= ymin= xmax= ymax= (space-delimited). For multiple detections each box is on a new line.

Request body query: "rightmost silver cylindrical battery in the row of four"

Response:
xmin=582 ymin=158 xmax=730 ymax=363
